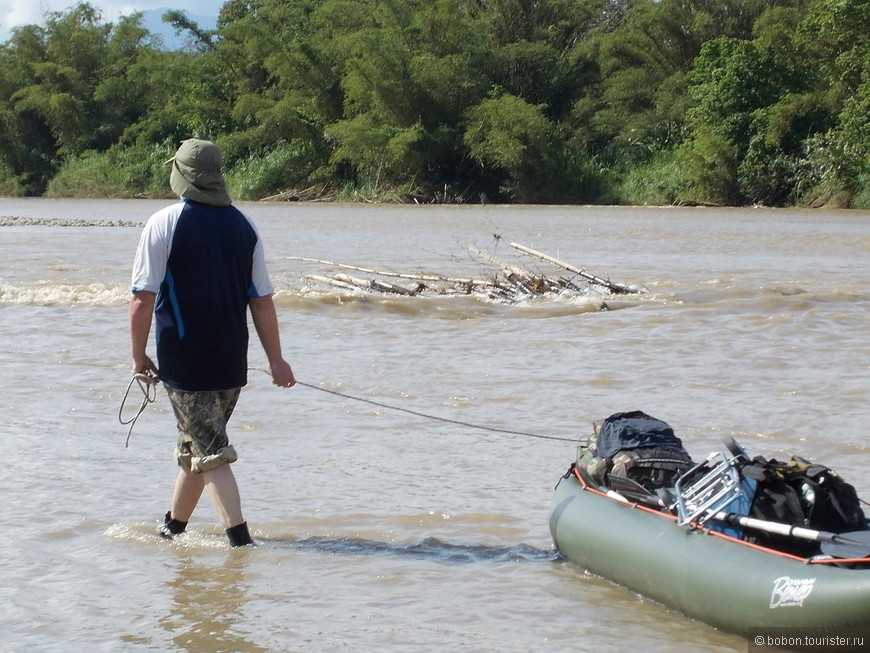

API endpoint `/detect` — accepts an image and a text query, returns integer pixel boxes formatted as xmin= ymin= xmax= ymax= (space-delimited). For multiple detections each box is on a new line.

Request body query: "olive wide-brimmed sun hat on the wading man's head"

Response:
xmin=167 ymin=138 xmax=233 ymax=206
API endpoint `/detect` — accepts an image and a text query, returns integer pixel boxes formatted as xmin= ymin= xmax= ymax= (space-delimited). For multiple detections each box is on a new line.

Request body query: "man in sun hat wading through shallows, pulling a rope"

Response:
xmin=130 ymin=139 xmax=296 ymax=546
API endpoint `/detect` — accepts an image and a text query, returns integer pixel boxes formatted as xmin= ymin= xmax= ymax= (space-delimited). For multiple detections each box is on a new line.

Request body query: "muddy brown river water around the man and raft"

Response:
xmin=0 ymin=200 xmax=870 ymax=652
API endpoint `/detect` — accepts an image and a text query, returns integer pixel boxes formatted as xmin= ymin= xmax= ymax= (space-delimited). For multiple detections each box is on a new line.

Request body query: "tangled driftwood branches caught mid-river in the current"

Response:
xmin=290 ymin=243 xmax=646 ymax=302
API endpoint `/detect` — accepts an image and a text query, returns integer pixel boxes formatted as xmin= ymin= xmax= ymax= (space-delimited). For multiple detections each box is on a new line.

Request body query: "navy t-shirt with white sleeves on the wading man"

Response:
xmin=133 ymin=200 xmax=272 ymax=391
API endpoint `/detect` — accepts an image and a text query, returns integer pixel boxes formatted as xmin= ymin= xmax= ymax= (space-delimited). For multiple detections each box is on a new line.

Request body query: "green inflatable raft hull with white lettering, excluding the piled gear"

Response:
xmin=550 ymin=466 xmax=870 ymax=636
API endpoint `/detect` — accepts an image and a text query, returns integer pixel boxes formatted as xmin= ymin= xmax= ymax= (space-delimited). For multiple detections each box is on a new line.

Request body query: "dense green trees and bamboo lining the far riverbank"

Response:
xmin=0 ymin=0 xmax=870 ymax=208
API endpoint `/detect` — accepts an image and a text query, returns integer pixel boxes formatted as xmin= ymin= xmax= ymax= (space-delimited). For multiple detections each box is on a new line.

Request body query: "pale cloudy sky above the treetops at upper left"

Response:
xmin=0 ymin=0 xmax=224 ymax=43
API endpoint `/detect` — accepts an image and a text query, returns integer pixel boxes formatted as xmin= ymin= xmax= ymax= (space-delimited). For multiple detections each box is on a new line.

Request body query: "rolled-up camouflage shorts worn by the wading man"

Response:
xmin=166 ymin=386 xmax=241 ymax=474
